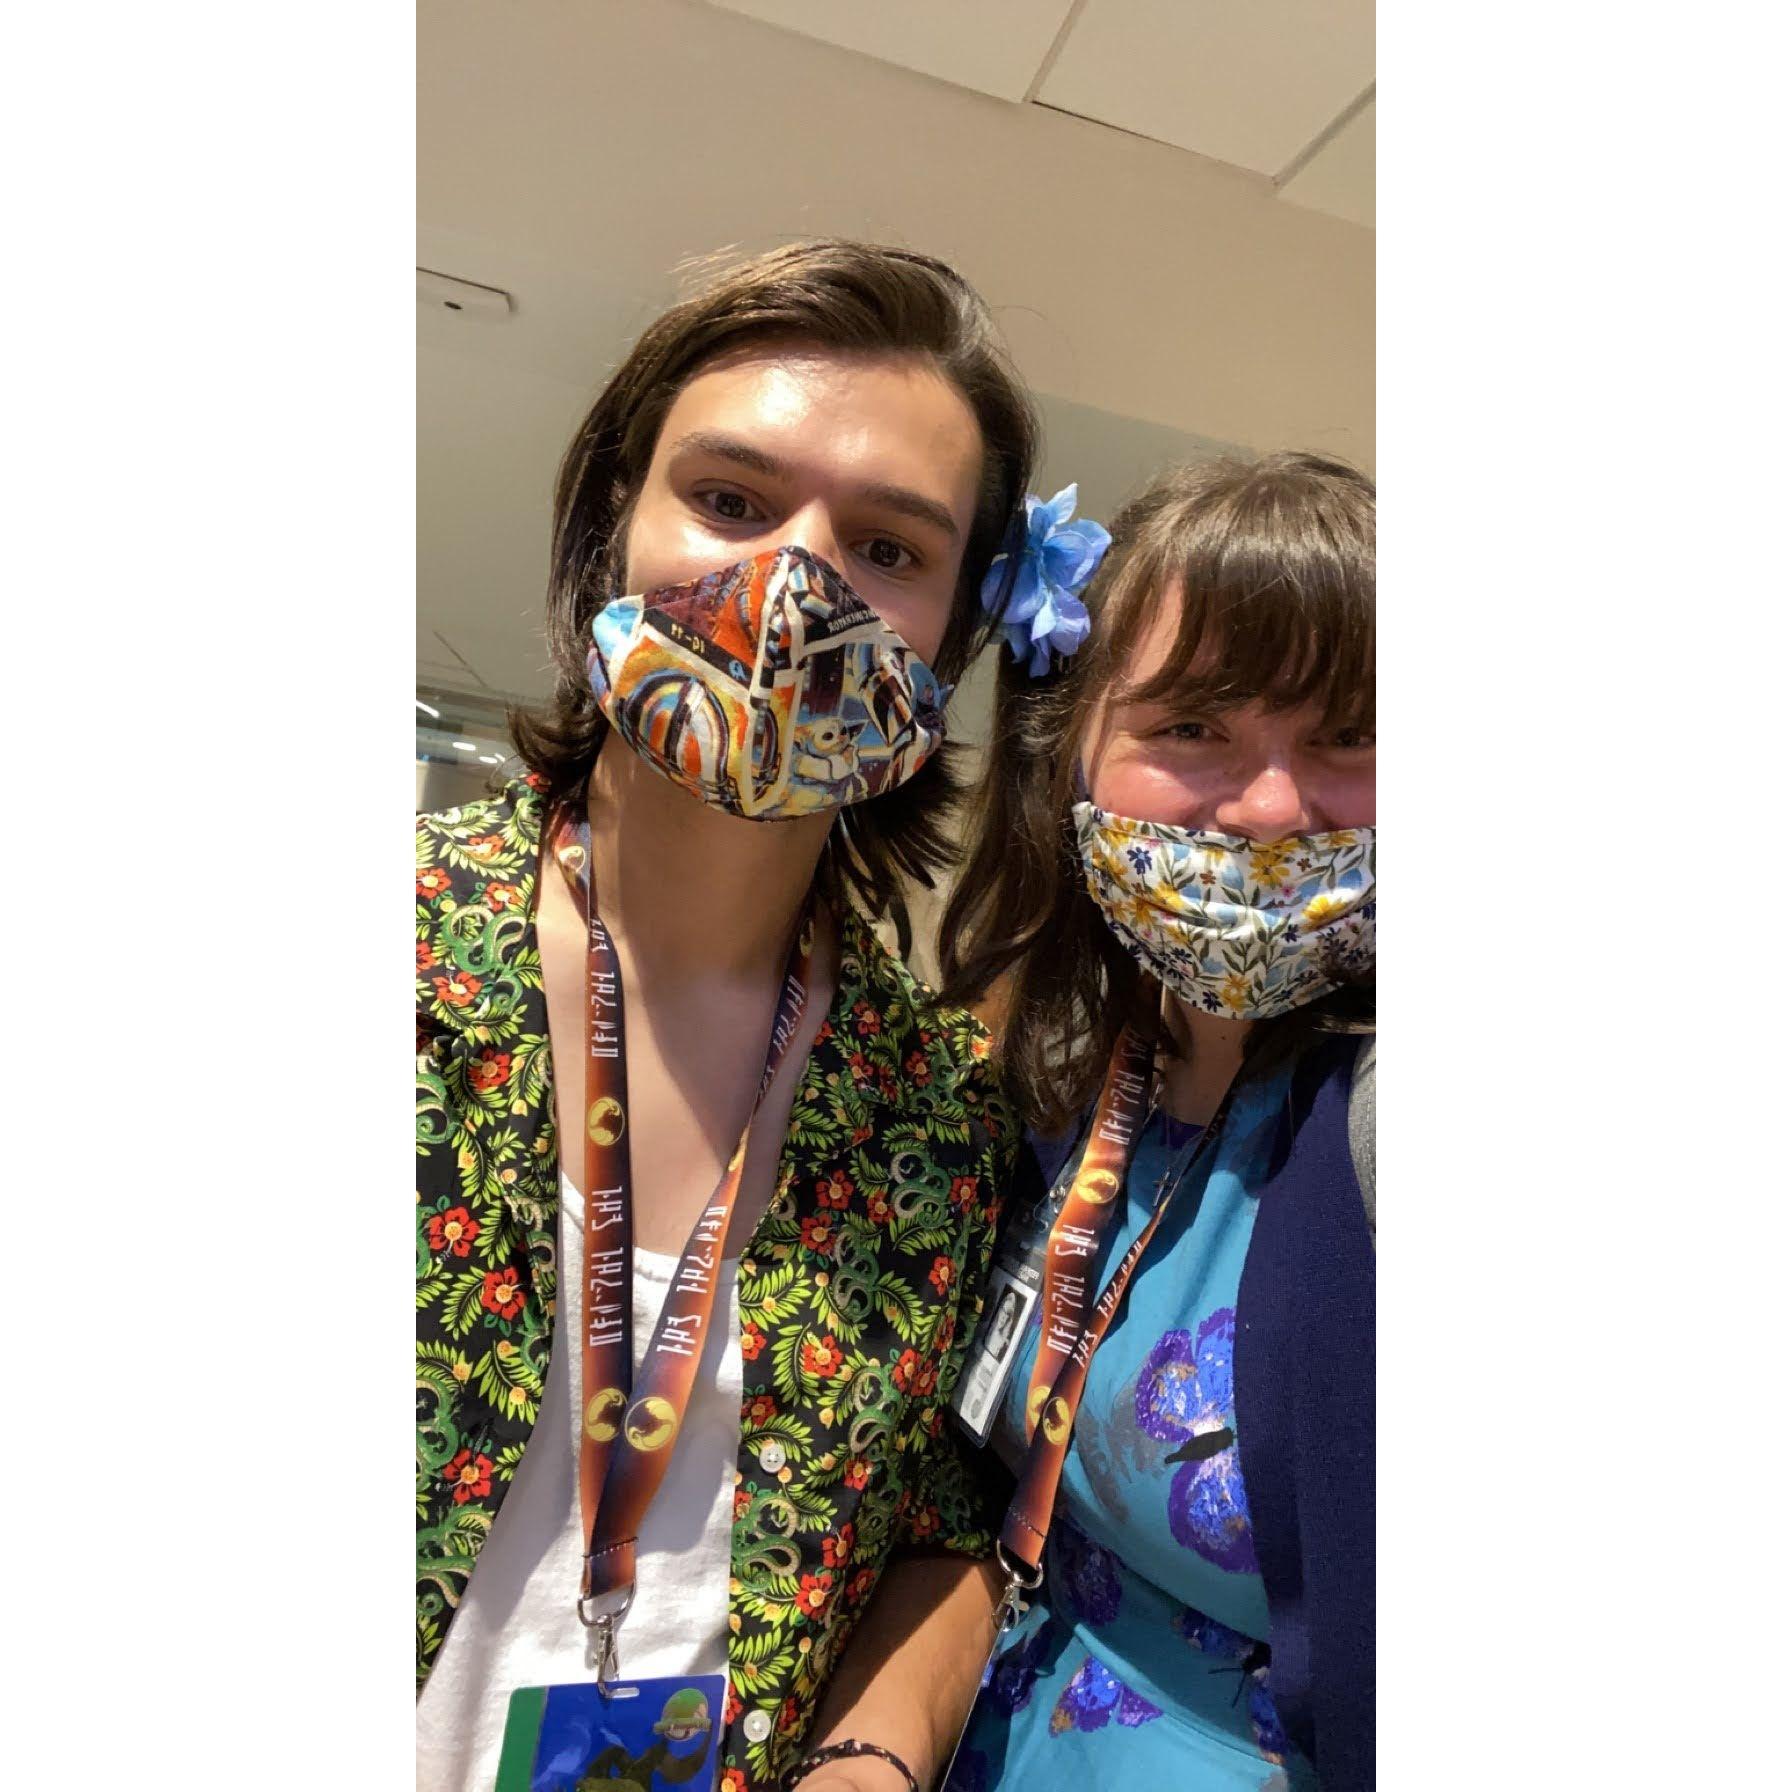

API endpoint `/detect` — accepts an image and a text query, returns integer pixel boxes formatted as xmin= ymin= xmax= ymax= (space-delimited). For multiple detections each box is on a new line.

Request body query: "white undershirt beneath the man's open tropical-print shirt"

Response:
xmin=418 ymin=1176 xmax=740 ymax=1792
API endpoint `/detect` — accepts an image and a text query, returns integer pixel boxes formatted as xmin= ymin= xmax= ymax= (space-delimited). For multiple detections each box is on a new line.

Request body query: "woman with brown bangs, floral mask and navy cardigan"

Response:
xmin=944 ymin=453 xmax=1374 ymax=1792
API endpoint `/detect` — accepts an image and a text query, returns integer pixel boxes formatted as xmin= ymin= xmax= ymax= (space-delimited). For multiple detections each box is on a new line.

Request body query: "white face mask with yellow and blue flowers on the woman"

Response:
xmin=1072 ymin=803 xmax=1374 ymax=1020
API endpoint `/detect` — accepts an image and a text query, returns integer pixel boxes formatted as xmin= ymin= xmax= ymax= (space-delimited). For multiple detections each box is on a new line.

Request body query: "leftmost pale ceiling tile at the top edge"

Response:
xmin=711 ymin=0 xmax=1073 ymax=100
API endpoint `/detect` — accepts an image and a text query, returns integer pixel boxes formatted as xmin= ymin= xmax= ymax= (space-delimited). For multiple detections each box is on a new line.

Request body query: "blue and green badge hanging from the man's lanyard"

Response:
xmin=493 ymin=1674 xmax=726 ymax=1792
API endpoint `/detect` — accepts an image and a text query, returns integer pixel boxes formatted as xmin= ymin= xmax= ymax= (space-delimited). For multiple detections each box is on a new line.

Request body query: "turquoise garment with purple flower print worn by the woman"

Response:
xmin=950 ymin=1075 xmax=1314 ymax=1792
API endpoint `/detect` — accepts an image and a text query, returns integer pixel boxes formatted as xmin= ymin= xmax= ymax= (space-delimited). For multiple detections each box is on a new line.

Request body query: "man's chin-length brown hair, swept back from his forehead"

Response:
xmin=511 ymin=238 xmax=1038 ymax=948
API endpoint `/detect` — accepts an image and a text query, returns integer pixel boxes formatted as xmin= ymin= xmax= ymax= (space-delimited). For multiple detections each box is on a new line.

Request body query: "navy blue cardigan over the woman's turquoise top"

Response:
xmin=1018 ymin=1039 xmax=1374 ymax=1792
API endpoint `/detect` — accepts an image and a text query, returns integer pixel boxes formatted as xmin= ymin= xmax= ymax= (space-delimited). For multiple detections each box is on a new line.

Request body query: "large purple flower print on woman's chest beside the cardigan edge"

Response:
xmin=1134 ymin=1306 xmax=1258 ymax=1573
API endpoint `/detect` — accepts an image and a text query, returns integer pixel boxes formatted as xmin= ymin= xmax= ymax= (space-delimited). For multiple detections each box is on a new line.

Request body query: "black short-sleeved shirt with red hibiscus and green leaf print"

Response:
xmin=418 ymin=780 xmax=1016 ymax=1792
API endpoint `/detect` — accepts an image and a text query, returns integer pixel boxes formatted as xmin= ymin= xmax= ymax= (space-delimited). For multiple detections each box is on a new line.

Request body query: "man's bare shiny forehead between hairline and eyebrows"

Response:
xmin=654 ymin=346 xmax=984 ymax=530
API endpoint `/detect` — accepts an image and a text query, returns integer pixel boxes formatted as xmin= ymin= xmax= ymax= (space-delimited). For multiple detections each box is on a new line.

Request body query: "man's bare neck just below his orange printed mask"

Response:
xmin=586 ymin=735 xmax=833 ymax=978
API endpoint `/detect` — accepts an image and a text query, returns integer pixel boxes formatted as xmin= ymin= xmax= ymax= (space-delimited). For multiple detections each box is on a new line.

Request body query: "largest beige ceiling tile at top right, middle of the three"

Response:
xmin=1038 ymin=0 xmax=1374 ymax=176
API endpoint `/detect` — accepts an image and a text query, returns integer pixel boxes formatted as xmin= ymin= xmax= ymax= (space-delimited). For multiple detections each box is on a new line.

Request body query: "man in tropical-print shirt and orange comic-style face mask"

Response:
xmin=418 ymin=242 xmax=1103 ymax=1792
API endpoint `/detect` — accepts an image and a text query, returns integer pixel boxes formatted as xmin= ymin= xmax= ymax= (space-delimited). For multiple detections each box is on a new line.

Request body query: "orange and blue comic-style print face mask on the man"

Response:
xmin=586 ymin=548 xmax=950 ymax=821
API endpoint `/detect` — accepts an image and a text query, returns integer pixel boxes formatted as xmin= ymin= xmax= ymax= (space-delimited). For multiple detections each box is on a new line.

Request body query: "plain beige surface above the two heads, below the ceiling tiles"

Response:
xmin=418 ymin=0 xmax=1374 ymax=694
